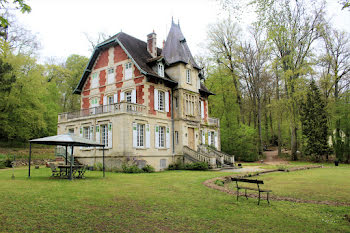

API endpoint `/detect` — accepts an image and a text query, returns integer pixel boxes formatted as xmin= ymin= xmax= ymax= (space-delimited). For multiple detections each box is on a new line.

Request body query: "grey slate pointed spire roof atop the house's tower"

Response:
xmin=162 ymin=22 xmax=200 ymax=69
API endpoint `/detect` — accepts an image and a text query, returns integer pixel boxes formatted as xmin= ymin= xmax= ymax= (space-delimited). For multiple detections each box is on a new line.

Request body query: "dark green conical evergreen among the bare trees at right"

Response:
xmin=300 ymin=80 xmax=329 ymax=161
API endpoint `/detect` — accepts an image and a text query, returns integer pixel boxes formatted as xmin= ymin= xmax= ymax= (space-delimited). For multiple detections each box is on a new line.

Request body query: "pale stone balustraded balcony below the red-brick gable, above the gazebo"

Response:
xmin=58 ymin=102 xmax=146 ymax=123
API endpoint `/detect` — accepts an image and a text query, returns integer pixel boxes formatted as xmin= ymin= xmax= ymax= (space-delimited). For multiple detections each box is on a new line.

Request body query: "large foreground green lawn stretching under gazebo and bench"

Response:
xmin=0 ymin=168 xmax=350 ymax=232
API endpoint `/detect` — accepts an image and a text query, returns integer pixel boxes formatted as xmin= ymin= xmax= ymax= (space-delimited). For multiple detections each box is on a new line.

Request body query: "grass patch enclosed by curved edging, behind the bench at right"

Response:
xmin=261 ymin=165 xmax=350 ymax=203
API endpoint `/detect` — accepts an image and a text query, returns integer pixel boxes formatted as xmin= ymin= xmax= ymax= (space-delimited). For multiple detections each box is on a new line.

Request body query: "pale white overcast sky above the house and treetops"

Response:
xmin=16 ymin=0 xmax=350 ymax=62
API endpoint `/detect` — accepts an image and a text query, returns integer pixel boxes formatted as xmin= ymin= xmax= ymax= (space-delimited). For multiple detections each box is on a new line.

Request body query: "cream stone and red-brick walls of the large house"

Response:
xmin=57 ymin=22 xmax=220 ymax=171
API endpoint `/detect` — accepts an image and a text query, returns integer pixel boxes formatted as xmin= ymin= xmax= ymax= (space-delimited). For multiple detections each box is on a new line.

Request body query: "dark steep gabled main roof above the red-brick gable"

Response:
xmin=74 ymin=32 xmax=177 ymax=94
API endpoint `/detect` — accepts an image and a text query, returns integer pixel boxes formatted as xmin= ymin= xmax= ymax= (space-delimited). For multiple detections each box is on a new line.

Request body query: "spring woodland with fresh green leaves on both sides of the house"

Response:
xmin=0 ymin=0 xmax=350 ymax=163
